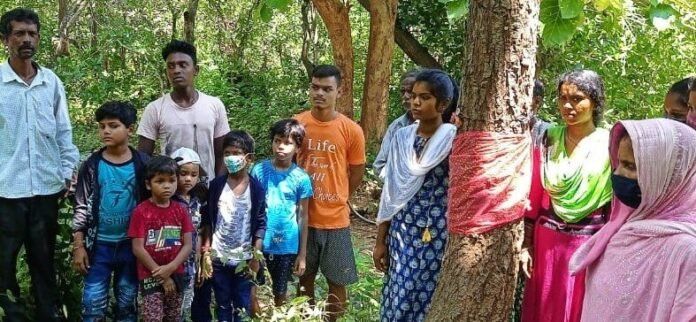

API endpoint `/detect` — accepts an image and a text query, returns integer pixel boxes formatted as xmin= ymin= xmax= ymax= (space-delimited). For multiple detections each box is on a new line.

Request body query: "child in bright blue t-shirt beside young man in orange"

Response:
xmin=251 ymin=119 xmax=312 ymax=306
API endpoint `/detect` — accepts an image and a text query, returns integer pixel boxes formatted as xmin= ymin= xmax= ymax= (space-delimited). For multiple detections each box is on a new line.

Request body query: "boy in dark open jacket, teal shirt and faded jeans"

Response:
xmin=72 ymin=102 xmax=149 ymax=322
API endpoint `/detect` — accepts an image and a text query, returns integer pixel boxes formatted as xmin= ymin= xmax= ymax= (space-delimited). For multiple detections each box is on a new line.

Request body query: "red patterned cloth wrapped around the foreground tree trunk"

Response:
xmin=447 ymin=132 xmax=532 ymax=235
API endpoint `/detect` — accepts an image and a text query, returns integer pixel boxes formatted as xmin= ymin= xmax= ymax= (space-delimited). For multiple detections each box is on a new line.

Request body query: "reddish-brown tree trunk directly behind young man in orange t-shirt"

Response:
xmin=312 ymin=0 xmax=353 ymax=118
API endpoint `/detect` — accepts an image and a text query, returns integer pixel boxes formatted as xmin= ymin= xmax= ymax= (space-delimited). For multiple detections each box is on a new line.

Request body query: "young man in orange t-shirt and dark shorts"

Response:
xmin=295 ymin=65 xmax=365 ymax=321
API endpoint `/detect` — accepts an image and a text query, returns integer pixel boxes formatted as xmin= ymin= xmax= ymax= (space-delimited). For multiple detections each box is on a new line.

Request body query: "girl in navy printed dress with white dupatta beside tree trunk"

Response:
xmin=373 ymin=69 xmax=457 ymax=322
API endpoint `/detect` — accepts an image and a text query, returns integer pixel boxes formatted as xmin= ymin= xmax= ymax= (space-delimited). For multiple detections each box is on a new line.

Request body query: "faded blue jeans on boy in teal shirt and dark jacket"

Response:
xmin=82 ymin=240 xmax=138 ymax=322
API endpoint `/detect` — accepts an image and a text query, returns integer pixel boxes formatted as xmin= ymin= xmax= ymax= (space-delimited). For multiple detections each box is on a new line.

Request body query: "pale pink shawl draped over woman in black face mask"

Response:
xmin=570 ymin=119 xmax=696 ymax=322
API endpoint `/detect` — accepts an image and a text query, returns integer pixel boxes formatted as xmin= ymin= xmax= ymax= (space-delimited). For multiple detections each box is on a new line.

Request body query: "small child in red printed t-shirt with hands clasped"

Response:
xmin=128 ymin=156 xmax=193 ymax=322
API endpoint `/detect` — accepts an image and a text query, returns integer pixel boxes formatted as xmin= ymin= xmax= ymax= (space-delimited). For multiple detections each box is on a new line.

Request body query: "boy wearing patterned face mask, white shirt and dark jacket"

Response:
xmin=202 ymin=131 xmax=266 ymax=321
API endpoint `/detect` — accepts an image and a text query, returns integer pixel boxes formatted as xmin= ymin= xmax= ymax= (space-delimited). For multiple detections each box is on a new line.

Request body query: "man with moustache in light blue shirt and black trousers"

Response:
xmin=0 ymin=8 xmax=80 ymax=322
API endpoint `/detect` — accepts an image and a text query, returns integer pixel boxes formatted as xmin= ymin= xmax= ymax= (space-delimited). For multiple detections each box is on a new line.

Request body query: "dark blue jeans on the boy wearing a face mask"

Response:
xmin=213 ymin=260 xmax=254 ymax=322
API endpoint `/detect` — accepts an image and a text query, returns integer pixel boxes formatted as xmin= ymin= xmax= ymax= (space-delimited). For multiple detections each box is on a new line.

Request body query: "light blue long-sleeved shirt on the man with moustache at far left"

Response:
xmin=0 ymin=63 xmax=79 ymax=198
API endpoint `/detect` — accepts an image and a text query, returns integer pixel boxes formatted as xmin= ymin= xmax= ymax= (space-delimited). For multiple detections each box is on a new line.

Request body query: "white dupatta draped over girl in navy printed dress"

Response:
xmin=377 ymin=123 xmax=457 ymax=224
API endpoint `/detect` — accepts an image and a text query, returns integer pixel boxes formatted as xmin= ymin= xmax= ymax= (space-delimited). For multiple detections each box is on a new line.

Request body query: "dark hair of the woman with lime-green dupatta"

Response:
xmin=556 ymin=69 xmax=604 ymax=126
